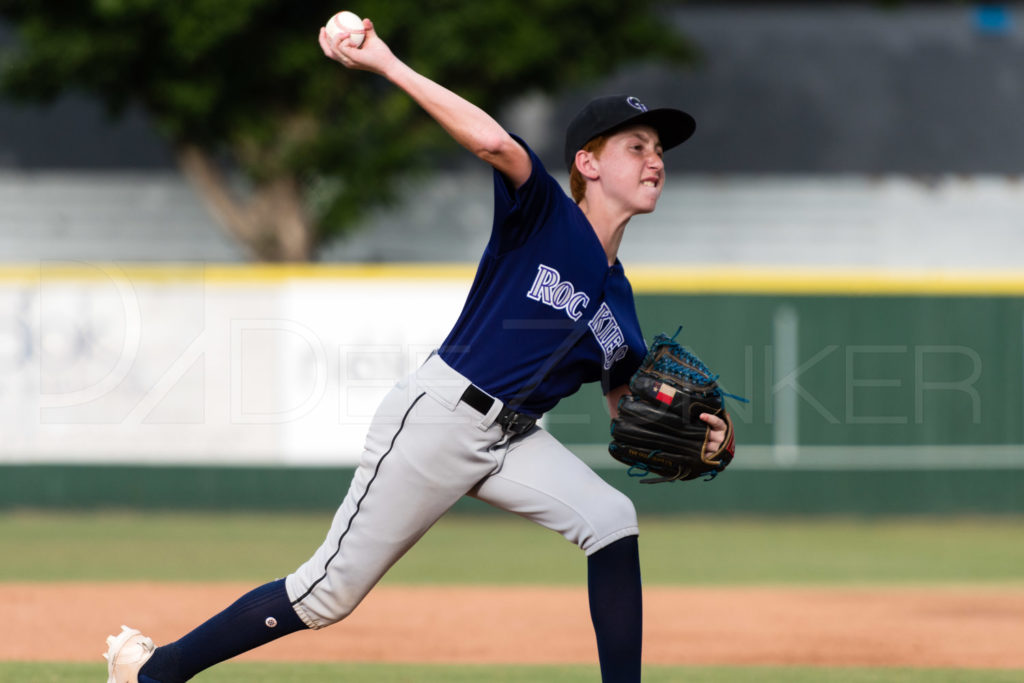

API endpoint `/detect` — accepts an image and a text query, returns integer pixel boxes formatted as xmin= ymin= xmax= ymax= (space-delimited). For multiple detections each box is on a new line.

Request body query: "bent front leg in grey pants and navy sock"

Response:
xmin=471 ymin=429 xmax=643 ymax=683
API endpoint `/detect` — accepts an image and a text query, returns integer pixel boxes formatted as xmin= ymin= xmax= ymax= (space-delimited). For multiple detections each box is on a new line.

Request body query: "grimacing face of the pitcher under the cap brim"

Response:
xmin=600 ymin=126 xmax=665 ymax=213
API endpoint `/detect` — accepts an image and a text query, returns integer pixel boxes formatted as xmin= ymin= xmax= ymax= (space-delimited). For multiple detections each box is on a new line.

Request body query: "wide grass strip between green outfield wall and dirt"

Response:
xmin=0 ymin=512 xmax=1024 ymax=585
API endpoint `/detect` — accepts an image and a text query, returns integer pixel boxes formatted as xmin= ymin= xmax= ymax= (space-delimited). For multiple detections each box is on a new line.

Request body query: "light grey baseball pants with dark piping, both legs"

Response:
xmin=286 ymin=354 xmax=638 ymax=629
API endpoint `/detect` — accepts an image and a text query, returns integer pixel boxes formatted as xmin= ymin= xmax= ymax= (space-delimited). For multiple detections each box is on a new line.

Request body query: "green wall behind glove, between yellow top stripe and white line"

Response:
xmin=551 ymin=294 xmax=1024 ymax=450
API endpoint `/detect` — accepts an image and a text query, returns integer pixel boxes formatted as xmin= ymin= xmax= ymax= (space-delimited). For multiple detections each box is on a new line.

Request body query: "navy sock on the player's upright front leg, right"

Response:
xmin=587 ymin=536 xmax=643 ymax=683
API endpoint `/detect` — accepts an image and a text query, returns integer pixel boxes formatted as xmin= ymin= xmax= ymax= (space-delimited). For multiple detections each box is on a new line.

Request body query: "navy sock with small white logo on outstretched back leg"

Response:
xmin=138 ymin=579 xmax=308 ymax=683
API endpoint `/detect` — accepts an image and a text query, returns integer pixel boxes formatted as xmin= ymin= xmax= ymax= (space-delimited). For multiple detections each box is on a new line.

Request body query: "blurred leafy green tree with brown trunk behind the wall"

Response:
xmin=0 ymin=0 xmax=690 ymax=261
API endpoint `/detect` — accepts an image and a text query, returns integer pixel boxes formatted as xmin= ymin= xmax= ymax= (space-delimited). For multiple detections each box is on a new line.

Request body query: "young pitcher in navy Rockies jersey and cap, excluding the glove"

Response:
xmin=105 ymin=15 xmax=725 ymax=683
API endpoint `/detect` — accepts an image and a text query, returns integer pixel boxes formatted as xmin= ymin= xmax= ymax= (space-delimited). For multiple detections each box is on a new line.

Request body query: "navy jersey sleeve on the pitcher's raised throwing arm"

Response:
xmin=487 ymin=135 xmax=572 ymax=255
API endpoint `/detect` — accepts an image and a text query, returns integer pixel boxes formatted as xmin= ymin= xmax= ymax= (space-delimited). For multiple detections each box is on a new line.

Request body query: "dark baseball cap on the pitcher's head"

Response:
xmin=565 ymin=95 xmax=697 ymax=170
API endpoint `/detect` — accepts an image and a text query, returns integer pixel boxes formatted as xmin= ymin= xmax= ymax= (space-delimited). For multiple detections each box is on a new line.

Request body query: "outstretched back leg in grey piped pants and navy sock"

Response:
xmin=131 ymin=366 xmax=504 ymax=683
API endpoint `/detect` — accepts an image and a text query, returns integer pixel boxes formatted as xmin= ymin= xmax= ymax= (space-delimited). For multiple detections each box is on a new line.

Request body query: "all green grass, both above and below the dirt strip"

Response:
xmin=0 ymin=512 xmax=1024 ymax=683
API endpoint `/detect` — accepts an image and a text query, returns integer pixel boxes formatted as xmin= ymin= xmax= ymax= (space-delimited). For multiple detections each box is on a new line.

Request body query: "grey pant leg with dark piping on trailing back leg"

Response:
xmin=287 ymin=374 xmax=506 ymax=629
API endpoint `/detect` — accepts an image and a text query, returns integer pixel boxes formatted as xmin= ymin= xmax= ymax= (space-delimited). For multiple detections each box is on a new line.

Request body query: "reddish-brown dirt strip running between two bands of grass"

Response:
xmin=0 ymin=583 xmax=1024 ymax=669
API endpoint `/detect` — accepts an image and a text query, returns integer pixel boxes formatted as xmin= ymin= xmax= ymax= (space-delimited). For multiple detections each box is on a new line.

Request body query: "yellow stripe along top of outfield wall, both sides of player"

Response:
xmin=0 ymin=262 xmax=1024 ymax=296
